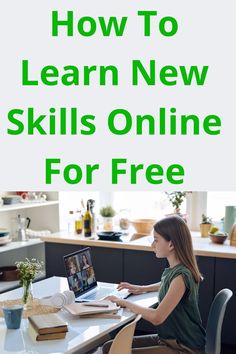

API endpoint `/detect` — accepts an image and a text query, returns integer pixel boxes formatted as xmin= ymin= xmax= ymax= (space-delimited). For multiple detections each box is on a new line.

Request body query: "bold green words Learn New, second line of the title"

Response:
xmin=22 ymin=60 xmax=208 ymax=86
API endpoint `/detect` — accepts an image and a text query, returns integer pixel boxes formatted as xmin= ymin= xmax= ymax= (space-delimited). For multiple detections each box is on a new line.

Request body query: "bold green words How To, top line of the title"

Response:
xmin=52 ymin=11 xmax=178 ymax=37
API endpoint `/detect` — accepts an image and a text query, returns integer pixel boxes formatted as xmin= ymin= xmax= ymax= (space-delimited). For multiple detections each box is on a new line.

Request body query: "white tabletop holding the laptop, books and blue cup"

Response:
xmin=0 ymin=277 xmax=157 ymax=354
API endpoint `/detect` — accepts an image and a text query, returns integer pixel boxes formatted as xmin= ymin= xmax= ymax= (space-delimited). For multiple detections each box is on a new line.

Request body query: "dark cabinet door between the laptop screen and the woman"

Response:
xmin=91 ymin=247 xmax=123 ymax=283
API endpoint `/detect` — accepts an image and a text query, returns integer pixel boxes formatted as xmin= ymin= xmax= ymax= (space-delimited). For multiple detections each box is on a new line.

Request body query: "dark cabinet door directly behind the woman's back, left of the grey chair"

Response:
xmin=197 ymin=257 xmax=215 ymax=327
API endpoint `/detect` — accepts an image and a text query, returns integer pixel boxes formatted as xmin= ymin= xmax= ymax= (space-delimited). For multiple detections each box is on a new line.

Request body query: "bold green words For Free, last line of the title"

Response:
xmin=45 ymin=158 xmax=184 ymax=185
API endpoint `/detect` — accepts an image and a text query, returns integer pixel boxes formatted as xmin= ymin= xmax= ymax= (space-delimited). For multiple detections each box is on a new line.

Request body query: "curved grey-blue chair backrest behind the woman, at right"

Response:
xmin=206 ymin=289 xmax=233 ymax=354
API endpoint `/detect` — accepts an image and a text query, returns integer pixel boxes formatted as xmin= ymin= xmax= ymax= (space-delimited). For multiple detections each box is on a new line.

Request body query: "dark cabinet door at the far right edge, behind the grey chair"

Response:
xmin=215 ymin=258 xmax=236 ymax=345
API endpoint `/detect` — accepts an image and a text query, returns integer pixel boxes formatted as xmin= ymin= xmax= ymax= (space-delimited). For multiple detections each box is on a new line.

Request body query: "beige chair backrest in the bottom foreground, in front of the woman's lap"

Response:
xmin=109 ymin=315 xmax=142 ymax=354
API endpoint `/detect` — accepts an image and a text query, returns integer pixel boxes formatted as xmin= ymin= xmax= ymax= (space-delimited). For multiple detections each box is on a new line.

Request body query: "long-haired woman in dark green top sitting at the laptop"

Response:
xmin=103 ymin=216 xmax=205 ymax=354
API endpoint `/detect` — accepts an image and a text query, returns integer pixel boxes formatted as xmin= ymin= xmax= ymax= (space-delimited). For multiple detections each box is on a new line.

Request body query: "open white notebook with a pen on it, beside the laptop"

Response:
xmin=64 ymin=300 xmax=120 ymax=316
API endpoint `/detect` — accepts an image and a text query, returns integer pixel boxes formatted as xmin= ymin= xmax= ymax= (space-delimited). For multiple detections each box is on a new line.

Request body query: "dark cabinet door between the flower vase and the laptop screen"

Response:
xmin=45 ymin=242 xmax=82 ymax=278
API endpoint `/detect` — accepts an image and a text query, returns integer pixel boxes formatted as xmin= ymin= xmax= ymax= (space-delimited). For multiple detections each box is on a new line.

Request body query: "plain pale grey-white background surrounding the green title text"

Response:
xmin=0 ymin=0 xmax=236 ymax=191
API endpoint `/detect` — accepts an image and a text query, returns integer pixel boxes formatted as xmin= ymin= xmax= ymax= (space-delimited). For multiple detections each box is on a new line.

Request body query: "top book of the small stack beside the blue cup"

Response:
xmin=28 ymin=313 xmax=68 ymax=334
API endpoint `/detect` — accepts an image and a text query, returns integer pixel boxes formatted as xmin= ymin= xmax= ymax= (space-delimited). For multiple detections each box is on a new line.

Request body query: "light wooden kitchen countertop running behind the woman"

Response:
xmin=41 ymin=231 xmax=236 ymax=259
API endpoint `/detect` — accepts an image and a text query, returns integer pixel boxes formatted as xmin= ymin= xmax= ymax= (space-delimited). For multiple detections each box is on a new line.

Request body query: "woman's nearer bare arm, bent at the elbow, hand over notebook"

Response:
xmin=108 ymin=275 xmax=186 ymax=325
